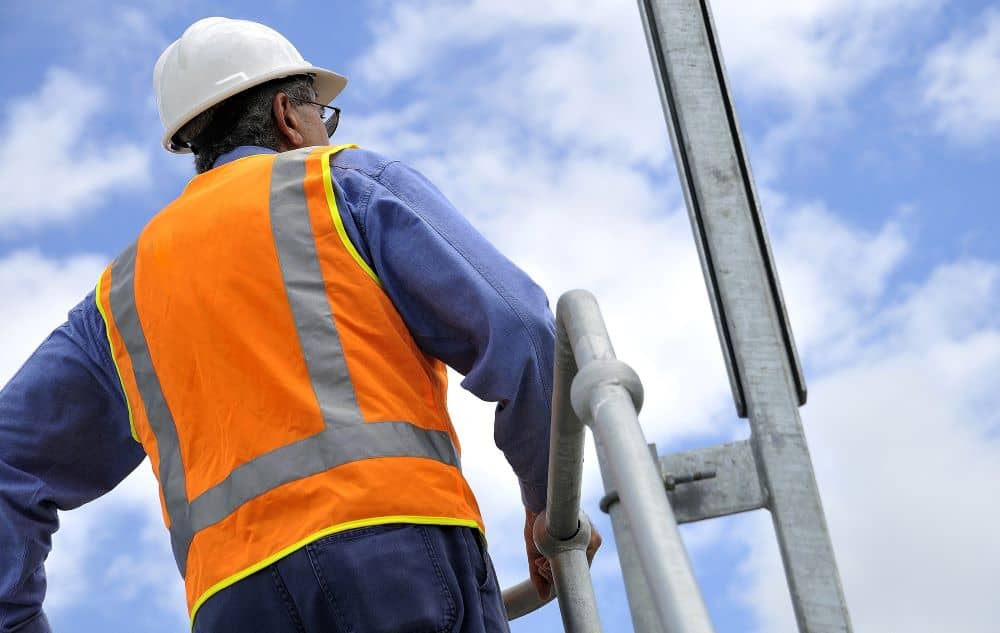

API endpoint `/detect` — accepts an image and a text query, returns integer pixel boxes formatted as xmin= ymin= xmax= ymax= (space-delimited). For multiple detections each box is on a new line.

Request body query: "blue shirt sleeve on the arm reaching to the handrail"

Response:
xmin=334 ymin=157 xmax=555 ymax=511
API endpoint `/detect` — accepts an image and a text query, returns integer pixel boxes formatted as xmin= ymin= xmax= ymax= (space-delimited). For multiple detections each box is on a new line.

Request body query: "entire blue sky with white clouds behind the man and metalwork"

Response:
xmin=0 ymin=0 xmax=1000 ymax=633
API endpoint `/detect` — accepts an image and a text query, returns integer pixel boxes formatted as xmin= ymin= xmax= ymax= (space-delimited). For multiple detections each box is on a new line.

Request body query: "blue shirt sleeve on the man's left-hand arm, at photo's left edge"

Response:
xmin=0 ymin=293 xmax=145 ymax=633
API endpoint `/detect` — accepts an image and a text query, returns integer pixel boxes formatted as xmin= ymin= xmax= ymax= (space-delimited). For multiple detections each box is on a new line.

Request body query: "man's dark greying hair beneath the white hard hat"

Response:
xmin=174 ymin=75 xmax=316 ymax=174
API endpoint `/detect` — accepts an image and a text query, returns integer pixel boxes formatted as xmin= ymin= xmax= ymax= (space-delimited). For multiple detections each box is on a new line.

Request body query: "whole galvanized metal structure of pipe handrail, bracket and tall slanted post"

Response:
xmin=504 ymin=0 xmax=852 ymax=633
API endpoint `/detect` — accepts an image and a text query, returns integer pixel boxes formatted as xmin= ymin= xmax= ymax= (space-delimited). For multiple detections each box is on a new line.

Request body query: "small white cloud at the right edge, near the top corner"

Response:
xmin=922 ymin=8 xmax=1000 ymax=145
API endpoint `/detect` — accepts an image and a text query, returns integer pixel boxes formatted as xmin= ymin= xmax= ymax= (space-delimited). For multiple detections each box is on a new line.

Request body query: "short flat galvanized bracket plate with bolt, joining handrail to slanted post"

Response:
xmin=660 ymin=441 xmax=767 ymax=523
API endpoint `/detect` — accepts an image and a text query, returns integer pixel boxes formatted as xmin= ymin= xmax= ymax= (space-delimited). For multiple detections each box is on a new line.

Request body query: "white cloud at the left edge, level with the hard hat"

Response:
xmin=0 ymin=68 xmax=149 ymax=229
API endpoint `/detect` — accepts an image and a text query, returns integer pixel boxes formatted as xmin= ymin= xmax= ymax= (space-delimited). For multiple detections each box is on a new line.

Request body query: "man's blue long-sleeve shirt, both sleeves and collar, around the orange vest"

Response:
xmin=0 ymin=147 xmax=555 ymax=633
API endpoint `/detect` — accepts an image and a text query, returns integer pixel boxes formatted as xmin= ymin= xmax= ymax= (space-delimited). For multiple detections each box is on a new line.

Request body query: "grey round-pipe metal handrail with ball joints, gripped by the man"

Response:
xmin=504 ymin=290 xmax=713 ymax=633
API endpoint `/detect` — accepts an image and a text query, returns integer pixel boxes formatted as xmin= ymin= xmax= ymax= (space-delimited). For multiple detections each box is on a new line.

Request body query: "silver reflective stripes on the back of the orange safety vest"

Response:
xmin=110 ymin=148 xmax=459 ymax=575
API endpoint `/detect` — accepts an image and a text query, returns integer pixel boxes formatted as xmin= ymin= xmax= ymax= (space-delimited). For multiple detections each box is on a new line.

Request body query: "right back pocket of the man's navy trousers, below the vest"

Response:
xmin=306 ymin=525 xmax=456 ymax=633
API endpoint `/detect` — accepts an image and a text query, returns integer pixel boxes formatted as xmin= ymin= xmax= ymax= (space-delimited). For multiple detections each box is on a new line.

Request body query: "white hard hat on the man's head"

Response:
xmin=153 ymin=18 xmax=347 ymax=153
